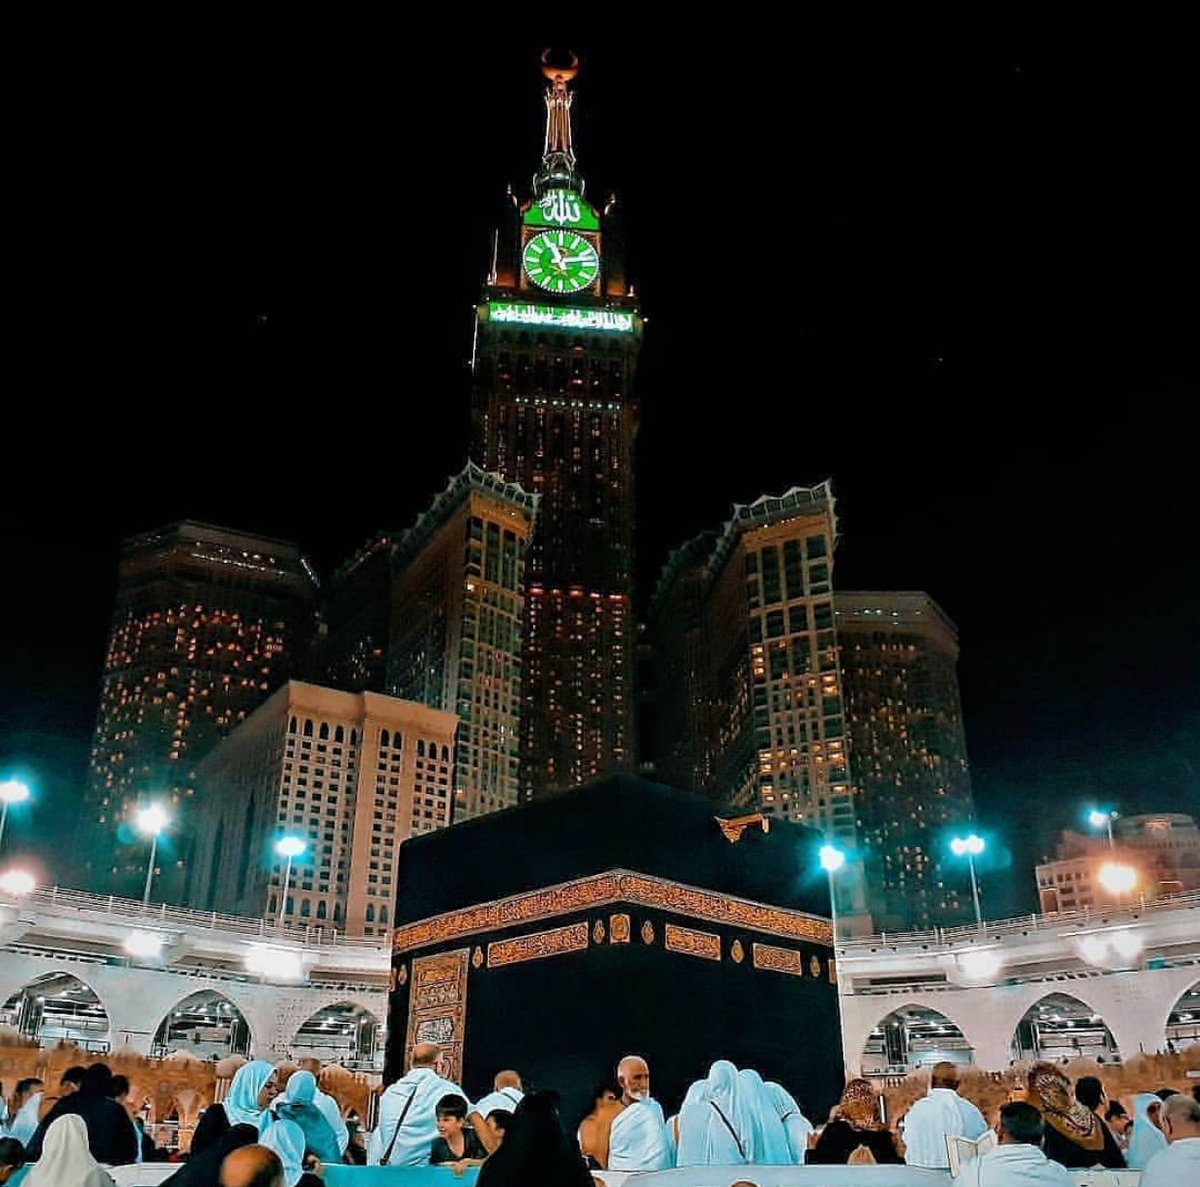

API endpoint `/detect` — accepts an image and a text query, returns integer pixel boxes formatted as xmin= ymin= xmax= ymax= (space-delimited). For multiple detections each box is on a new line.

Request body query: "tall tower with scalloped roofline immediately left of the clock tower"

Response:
xmin=386 ymin=464 xmax=538 ymax=820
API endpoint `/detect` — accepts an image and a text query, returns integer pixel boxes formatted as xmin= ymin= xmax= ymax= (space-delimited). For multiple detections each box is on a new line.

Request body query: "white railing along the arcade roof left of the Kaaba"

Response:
xmin=4 ymin=886 xmax=390 ymax=952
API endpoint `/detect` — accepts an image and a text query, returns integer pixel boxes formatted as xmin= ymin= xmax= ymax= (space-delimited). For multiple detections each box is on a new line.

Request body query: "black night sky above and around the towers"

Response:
xmin=0 ymin=29 xmax=1200 ymax=912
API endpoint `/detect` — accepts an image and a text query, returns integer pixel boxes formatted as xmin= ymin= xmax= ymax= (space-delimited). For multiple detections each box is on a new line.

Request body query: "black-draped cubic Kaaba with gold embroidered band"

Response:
xmin=385 ymin=777 xmax=842 ymax=1123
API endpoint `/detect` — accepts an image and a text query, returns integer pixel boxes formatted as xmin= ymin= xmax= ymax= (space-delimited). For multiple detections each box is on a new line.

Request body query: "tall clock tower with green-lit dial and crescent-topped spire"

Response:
xmin=467 ymin=50 xmax=642 ymax=798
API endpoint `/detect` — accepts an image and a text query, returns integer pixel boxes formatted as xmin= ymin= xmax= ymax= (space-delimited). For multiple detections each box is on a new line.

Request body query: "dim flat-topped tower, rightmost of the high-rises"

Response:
xmin=834 ymin=592 xmax=974 ymax=931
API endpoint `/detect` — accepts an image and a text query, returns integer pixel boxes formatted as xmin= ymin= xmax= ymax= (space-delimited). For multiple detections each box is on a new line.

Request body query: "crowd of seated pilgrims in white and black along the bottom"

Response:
xmin=0 ymin=1044 xmax=1200 ymax=1187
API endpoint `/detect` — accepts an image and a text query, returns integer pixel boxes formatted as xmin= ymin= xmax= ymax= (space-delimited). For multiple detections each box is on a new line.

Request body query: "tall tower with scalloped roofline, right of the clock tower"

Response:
xmin=652 ymin=482 xmax=857 ymax=846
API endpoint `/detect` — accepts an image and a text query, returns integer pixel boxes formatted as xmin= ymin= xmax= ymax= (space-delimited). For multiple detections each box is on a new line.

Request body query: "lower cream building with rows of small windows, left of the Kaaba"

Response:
xmin=187 ymin=681 xmax=458 ymax=936
